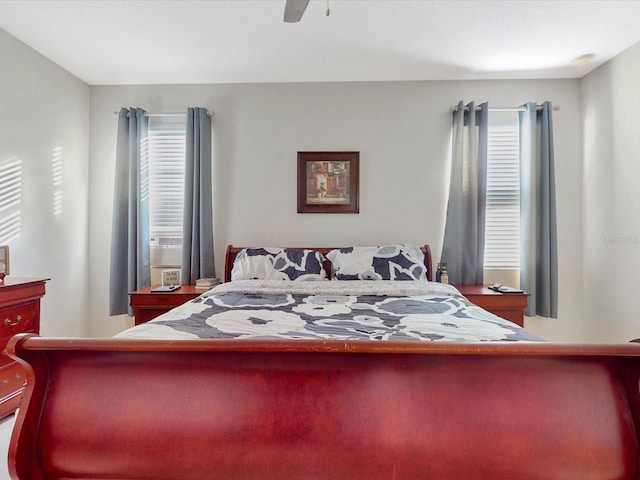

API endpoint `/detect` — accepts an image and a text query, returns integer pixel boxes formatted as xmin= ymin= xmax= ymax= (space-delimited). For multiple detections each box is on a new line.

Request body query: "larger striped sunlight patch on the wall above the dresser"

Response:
xmin=0 ymin=157 xmax=22 ymax=244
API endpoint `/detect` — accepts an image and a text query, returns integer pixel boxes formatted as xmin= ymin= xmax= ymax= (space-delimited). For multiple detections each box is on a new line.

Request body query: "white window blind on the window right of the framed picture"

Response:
xmin=484 ymin=112 xmax=520 ymax=269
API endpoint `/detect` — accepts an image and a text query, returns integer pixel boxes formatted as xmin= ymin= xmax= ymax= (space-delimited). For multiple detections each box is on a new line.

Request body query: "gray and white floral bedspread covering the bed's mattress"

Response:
xmin=117 ymin=280 xmax=542 ymax=342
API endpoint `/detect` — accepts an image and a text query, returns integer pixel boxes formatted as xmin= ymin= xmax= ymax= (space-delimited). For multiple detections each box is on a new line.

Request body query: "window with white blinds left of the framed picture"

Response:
xmin=149 ymin=117 xmax=185 ymax=266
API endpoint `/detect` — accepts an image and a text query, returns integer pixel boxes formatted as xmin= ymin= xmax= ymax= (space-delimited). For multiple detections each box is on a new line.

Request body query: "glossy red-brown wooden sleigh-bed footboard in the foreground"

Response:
xmin=8 ymin=335 xmax=640 ymax=480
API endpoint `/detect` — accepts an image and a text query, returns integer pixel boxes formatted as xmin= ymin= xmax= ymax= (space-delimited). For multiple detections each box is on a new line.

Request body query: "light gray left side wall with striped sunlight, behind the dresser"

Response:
xmin=0 ymin=30 xmax=89 ymax=336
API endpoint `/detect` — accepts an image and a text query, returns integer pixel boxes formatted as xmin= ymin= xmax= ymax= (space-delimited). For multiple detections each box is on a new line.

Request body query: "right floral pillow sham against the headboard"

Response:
xmin=327 ymin=244 xmax=427 ymax=280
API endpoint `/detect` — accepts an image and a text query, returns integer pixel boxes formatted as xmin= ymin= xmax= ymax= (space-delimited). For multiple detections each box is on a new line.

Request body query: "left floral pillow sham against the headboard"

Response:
xmin=231 ymin=247 xmax=327 ymax=281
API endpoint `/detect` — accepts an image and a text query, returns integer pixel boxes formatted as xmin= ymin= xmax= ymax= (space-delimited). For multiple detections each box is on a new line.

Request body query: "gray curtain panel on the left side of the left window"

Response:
xmin=109 ymin=108 xmax=151 ymax=316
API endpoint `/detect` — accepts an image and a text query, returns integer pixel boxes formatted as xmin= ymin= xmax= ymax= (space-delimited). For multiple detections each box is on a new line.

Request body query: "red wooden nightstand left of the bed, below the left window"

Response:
xmin=129 ymin=285 xmax=206 ymax=325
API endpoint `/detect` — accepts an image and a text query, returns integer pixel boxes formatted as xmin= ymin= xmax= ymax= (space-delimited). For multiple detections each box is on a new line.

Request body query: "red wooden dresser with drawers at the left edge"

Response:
xmin=0 ymin=277 xmax=48 ymax=418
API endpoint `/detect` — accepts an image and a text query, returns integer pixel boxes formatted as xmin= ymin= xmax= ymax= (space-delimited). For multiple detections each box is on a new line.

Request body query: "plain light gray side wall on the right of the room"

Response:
xmin=582 ymin=40 xmax=640 ymax=342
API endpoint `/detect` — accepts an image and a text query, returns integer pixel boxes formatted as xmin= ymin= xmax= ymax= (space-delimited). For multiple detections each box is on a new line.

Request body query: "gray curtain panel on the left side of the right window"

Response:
xmin=440 ymin=102 xmax=489 ymax=285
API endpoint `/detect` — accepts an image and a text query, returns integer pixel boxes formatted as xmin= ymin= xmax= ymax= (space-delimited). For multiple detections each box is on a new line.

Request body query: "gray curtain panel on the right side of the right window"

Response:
xmin=519 ymin=102 xmax=558 ymax=318
